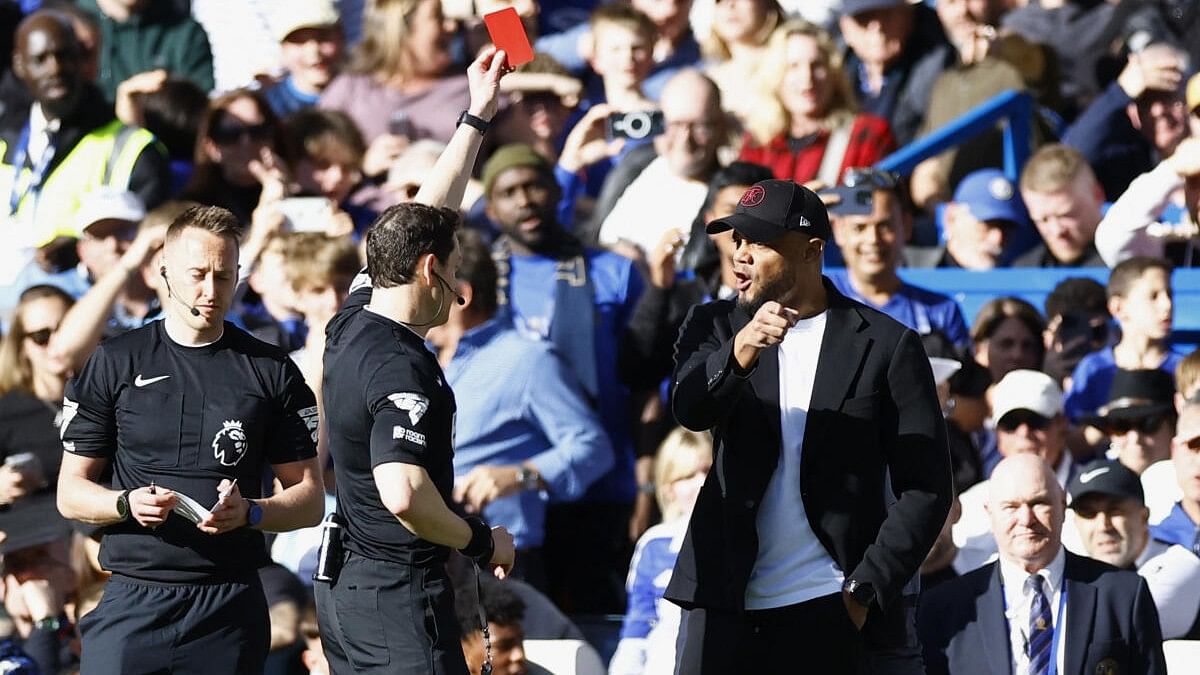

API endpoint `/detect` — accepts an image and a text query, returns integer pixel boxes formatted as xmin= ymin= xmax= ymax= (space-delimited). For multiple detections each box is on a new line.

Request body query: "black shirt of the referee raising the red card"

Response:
xmin=323 ymin=274 xmax=455 ymax=566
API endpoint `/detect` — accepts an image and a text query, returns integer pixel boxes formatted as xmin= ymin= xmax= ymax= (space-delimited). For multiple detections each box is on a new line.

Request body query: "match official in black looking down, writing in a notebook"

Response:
xmin=58 ymin=207 xmax=323 ymax=675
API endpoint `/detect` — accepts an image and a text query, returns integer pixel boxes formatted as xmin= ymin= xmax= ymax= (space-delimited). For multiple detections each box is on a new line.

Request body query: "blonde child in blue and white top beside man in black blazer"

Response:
xmin=608 ymin=428 xmax=713 ymax=675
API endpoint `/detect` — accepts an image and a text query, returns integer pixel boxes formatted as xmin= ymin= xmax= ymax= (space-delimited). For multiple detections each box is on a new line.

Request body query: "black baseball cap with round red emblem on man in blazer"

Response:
xmin=704 ymin=179 xmax=832 ymax=243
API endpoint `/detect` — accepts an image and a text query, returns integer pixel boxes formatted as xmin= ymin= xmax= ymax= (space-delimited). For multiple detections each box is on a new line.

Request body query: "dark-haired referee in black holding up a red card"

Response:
xmin=314 ymin=44 xmax=514 ymax=675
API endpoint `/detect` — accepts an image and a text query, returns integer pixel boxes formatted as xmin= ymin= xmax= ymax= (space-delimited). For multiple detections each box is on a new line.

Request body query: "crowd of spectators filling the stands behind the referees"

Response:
xmin=0 ymin=0 xmax=1200 ymax=674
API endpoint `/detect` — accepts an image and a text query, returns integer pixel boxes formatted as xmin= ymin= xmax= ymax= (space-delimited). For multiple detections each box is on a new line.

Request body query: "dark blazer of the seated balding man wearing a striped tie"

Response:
xmin=917 ymin=551 xmax=1166 ymax=675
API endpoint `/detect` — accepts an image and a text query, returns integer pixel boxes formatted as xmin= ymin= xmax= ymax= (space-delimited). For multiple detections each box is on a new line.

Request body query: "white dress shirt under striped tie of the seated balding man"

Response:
xmin=1000 ymin=545 xmax=1067 ymax=675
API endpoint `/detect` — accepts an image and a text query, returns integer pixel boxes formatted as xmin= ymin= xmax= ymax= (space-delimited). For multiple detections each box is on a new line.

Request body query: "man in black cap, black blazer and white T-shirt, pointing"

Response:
xmin=665 ymin=180 xmax=952 ymax=675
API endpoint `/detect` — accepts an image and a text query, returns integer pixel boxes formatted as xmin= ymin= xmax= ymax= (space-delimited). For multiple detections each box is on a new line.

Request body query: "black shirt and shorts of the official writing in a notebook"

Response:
xmin=61 ymin=321 xmax=317 ymax=675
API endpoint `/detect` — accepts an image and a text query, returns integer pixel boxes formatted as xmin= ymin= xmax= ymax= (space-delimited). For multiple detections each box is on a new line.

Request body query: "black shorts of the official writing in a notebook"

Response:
xmin=79 ymin=574 xmax=271 ymax=675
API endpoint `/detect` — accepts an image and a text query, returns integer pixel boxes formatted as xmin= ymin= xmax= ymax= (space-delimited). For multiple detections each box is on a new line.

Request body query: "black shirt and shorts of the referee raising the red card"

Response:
xmin=314 ymin=275 xmax=467 ymax=675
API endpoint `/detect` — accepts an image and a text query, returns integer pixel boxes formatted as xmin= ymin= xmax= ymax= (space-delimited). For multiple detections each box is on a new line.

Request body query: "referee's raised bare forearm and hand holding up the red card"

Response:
xmin=414 ymin=47 xmax=505 ymax=208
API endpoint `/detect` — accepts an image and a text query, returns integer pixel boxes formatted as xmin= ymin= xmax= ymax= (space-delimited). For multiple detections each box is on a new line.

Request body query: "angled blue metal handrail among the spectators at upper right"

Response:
xmin=875 ymin=90 xmax=1033 ymax=183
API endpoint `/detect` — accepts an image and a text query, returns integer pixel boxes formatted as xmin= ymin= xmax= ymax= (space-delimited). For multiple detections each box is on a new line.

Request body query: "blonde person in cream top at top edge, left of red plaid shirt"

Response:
xmin=701 ymin=0 xmax=784 ymax=121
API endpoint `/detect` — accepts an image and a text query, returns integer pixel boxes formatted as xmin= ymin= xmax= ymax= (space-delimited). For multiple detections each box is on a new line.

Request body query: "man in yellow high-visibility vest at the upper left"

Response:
xmin=0 ymin=11 xmax=170 ymax=278
